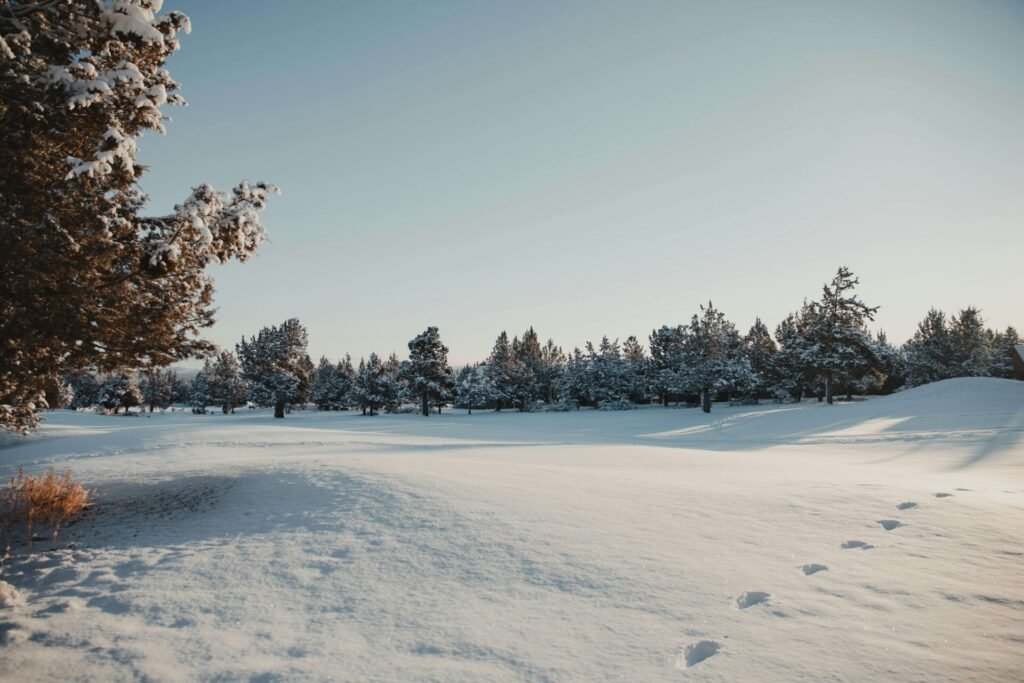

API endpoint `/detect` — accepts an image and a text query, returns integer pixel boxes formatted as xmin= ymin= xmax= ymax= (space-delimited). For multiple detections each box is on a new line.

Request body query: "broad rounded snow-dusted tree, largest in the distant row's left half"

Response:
xmin=236 ymin=317 xmax=312 ymax=418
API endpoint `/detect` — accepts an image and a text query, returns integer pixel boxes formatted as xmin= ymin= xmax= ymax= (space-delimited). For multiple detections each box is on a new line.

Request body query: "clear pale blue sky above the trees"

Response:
xmin=139 ymin=0 xmax=1024 ymax=364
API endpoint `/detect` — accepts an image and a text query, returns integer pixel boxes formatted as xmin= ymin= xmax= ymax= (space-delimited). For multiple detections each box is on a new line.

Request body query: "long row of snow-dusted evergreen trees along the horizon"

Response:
xmin=54 ymin=267 xmax=1020 ymax=418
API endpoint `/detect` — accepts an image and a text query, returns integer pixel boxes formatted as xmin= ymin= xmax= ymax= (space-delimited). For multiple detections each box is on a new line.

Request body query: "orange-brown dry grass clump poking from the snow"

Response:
xmin=0 ymin=467 xmax=89 ymax=545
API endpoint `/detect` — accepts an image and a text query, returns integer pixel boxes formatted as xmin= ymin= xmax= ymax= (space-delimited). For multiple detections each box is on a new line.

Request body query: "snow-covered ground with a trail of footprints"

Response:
xmin=0 ymin=379 xmax=1024 ymax=681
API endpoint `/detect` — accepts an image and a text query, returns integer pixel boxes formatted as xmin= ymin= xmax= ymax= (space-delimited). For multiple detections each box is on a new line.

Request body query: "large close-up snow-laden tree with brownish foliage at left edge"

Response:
xmin=0 ymin=0 xmax=274 ymax=431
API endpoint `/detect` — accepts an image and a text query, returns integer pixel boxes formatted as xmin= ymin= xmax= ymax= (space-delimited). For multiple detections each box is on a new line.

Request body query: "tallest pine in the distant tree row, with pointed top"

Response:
xmin=805 ymin=266 xmax=879 ymax=403
